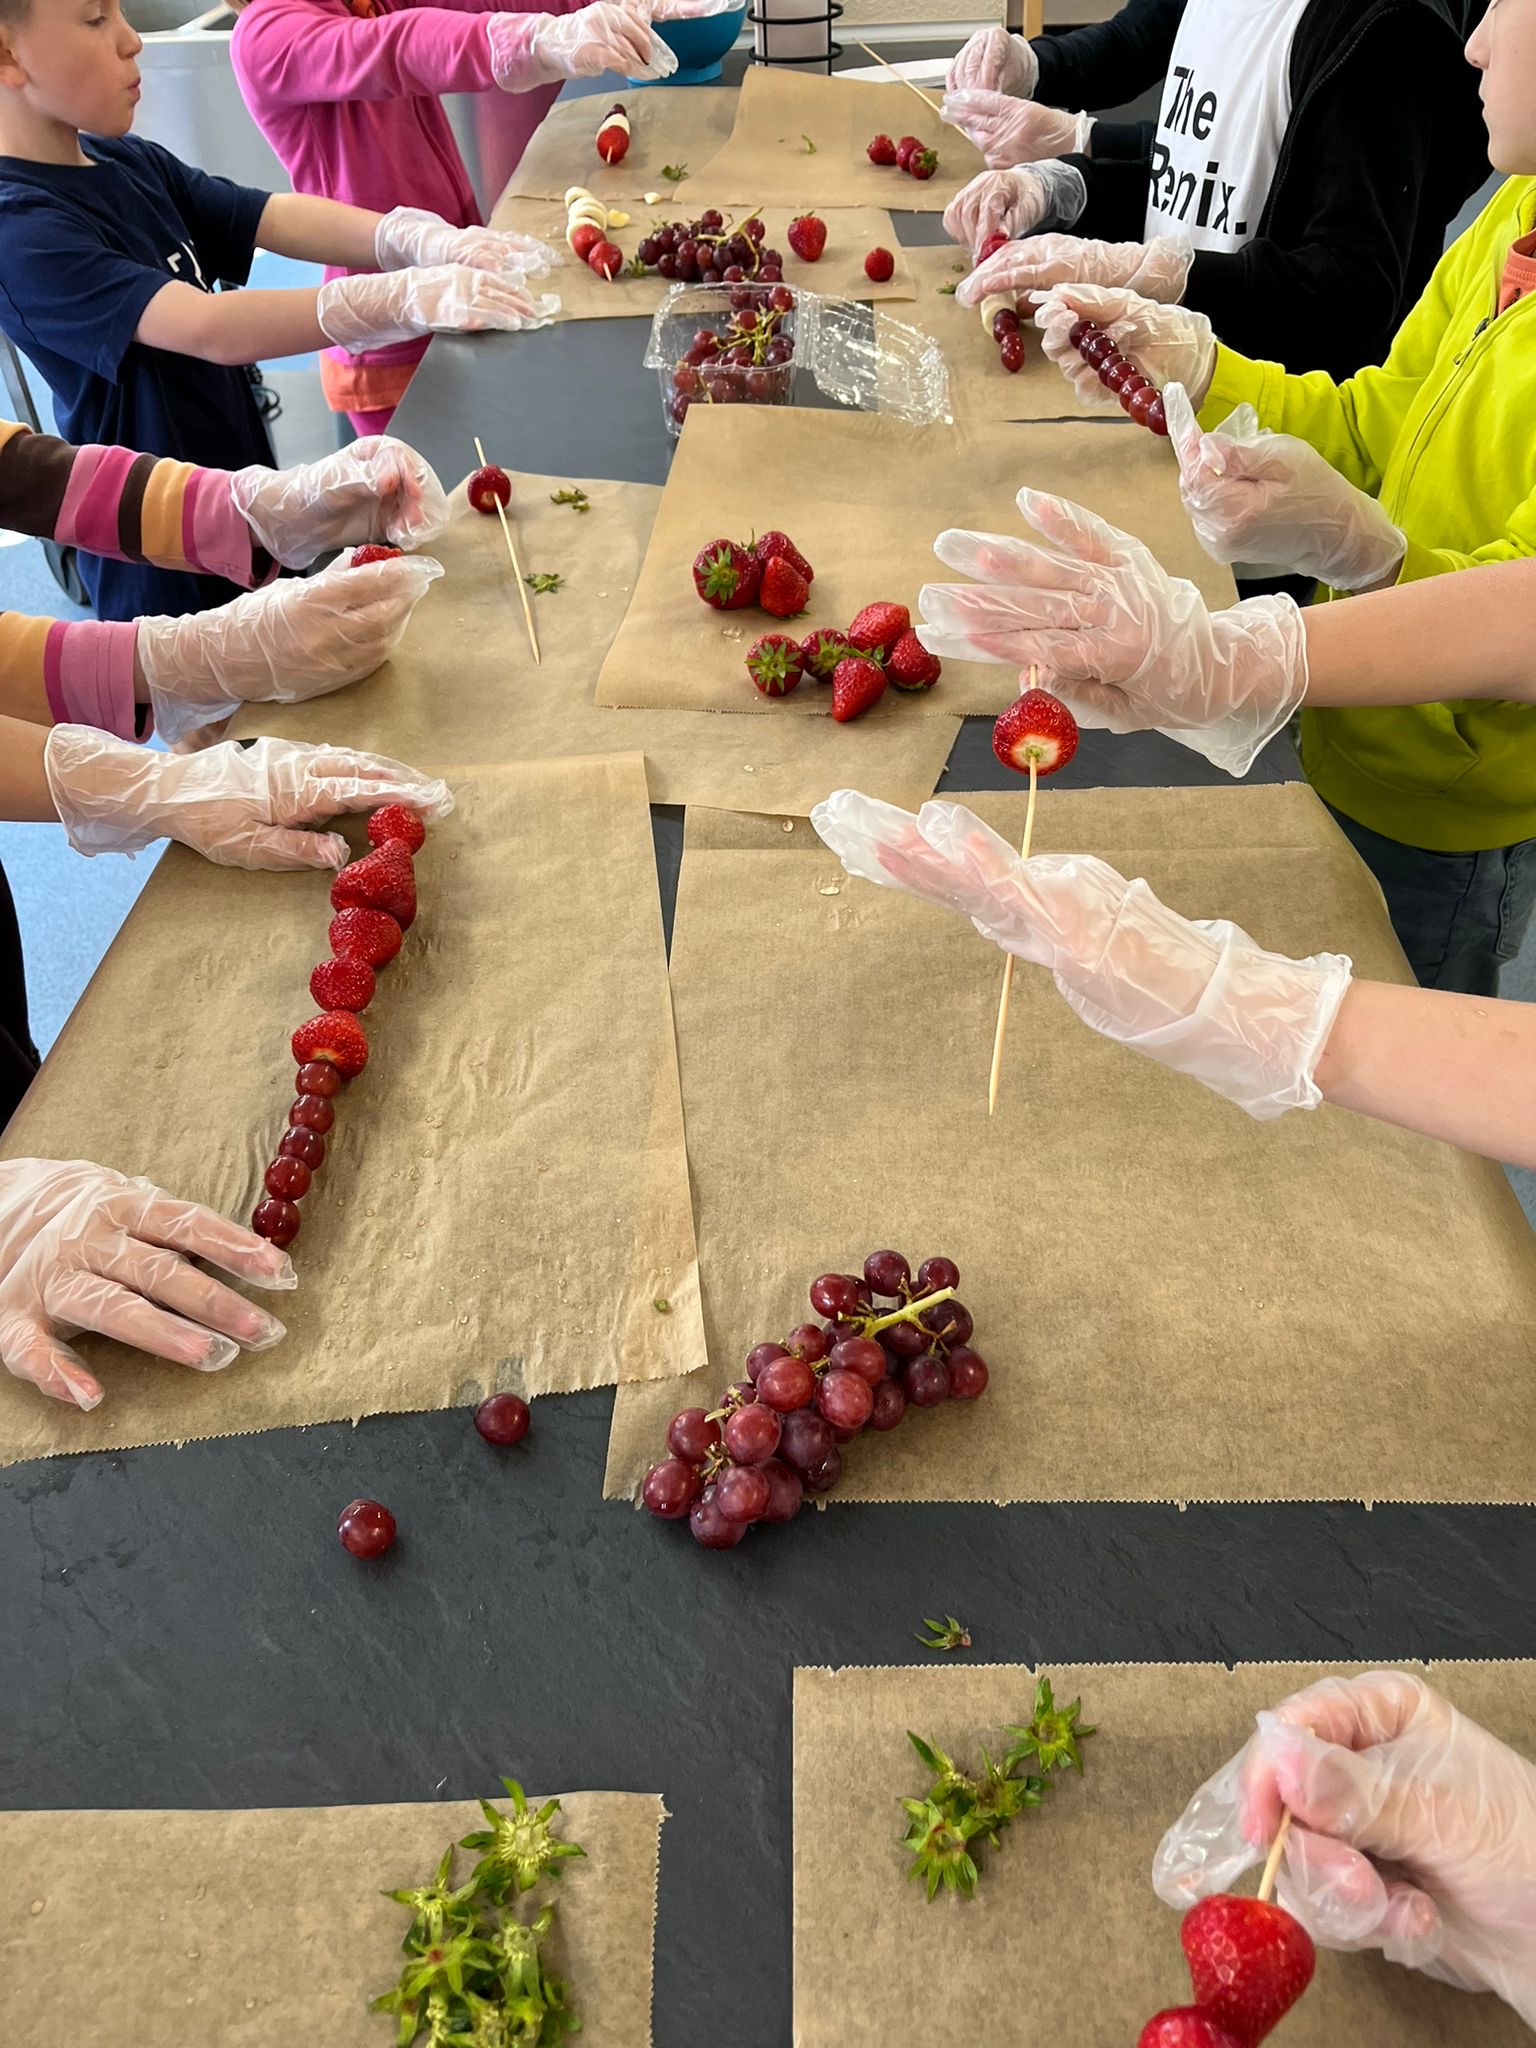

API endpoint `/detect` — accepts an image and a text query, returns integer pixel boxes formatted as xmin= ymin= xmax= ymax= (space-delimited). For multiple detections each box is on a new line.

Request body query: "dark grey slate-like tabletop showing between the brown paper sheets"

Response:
xmin=0 ymin=51 xmax=1536 ymax=2048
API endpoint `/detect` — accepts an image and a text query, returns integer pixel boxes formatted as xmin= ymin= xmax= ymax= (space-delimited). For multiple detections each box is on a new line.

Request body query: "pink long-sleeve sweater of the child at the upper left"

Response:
xmin=231 ymin=0 xmax=582 ymax=412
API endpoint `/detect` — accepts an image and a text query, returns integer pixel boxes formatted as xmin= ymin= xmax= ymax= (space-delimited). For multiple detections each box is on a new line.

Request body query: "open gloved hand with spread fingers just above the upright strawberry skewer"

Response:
xmin=918 ymin=487 xmax=1307 ymax=776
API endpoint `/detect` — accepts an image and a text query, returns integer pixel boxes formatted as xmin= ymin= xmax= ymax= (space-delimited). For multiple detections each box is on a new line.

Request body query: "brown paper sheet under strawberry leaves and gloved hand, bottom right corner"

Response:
xmin=795 ymin=1659 xmax=1536 ymax=2048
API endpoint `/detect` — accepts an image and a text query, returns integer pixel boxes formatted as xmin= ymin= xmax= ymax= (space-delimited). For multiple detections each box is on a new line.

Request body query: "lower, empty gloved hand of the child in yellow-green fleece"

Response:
xmin=1163 ymin=383 xmax=1407 ymax=590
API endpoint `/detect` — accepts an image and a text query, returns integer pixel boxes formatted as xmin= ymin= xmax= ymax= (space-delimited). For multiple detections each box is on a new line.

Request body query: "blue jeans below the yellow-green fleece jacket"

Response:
xmin=1329 ymin=805 xmax=1536 ymax=995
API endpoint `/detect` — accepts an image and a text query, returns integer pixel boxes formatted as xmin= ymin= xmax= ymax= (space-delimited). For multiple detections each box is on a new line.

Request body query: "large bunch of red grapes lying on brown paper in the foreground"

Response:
xmin=641 ymin=1251 xmax=987 ymax=1550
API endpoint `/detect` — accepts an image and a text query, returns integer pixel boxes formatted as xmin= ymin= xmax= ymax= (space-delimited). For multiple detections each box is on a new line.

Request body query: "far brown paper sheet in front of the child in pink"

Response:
xmin=498 ymin=86 xmax=737 ymax=203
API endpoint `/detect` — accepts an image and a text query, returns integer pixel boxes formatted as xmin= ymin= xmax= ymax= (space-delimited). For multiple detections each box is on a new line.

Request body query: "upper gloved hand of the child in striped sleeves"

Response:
xmin=229 ymin=434 xmax=449 ymax=569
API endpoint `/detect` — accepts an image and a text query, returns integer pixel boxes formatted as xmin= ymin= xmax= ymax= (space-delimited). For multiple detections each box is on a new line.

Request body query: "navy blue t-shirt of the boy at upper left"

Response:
xmin=0 ymin=135 xmax=272 ymax=618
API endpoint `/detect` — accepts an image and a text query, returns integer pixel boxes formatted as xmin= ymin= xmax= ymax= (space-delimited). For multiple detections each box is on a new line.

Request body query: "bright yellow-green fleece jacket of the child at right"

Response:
xmin=1200 ymin=178 xmax=1536 ymax=854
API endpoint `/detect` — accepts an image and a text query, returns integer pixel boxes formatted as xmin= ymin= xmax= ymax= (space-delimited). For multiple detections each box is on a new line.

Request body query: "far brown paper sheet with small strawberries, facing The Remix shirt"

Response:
xmin=684 ymin=66 xmax=987 ymax=213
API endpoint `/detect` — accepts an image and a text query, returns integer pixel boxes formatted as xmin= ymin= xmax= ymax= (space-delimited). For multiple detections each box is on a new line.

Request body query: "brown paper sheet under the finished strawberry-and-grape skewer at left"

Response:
xmin=0 ymin=754 xmax=705 ymax=1462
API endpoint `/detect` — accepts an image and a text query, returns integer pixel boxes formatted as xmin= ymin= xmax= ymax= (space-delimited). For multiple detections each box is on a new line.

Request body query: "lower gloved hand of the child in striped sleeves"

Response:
xmin=137 ymin=555 xmax=442 ymax=745
